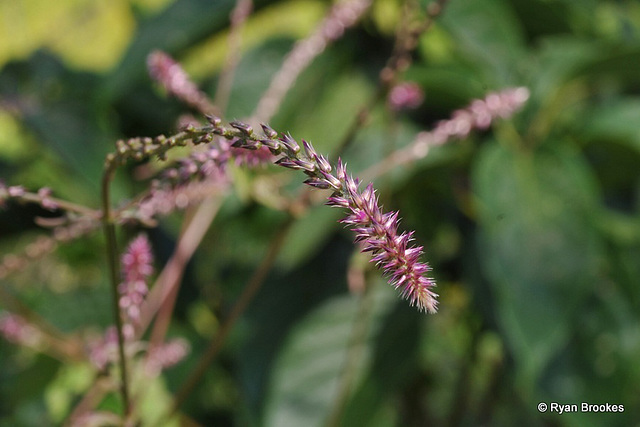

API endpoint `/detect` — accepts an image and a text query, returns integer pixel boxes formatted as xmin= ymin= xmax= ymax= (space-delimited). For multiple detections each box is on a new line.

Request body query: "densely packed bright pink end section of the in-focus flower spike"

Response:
xmin=327 ymin=160 xmax=438 ymax=313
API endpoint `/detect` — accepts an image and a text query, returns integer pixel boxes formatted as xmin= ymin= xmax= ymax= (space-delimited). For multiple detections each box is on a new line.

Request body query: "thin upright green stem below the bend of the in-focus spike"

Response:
xmin=102 ymin=160 xmax=131 ymax=417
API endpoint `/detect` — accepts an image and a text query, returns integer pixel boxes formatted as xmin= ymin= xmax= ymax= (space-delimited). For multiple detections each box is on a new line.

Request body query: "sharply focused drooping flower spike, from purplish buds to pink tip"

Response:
xmin=220 ymin=124 xmax=438 ymax=313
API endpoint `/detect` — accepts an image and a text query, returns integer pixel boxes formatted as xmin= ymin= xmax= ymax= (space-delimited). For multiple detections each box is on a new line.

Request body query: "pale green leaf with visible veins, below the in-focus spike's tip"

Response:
xmin=263 ymin=280 xmax=394 ymax=427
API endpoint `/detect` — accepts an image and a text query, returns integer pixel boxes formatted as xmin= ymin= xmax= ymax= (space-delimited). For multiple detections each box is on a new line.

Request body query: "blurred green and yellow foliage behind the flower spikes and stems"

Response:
xmin=0 ymin=0 xmax=640 ymax=426
